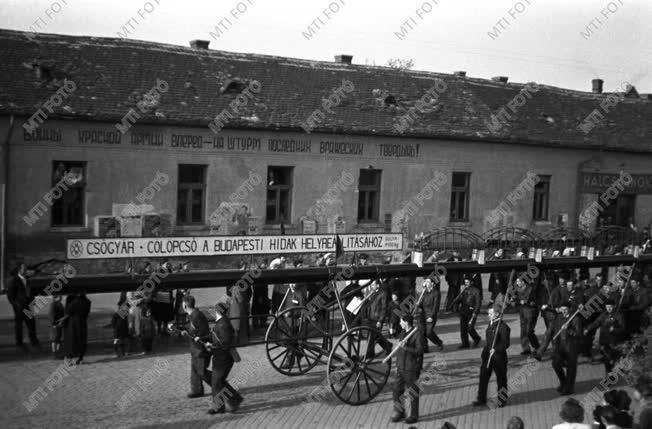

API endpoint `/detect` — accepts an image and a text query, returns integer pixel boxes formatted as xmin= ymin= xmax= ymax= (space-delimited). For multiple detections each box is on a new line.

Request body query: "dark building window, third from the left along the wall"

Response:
xmin=265 ymin=167 xmax=294 ymax=224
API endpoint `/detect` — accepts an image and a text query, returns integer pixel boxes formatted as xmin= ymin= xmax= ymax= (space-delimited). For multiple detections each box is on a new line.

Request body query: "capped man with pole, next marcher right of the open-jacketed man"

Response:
xmin=533 ymin=302 xmax=582 ymax=396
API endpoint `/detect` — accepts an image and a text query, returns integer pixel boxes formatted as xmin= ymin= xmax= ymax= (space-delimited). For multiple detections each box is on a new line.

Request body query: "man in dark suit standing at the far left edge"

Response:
xmin=7 ymin=262 xmax=39 ymax=347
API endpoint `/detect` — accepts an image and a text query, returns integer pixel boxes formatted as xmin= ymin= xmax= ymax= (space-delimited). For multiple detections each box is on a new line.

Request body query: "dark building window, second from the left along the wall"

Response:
xmin=177 ymin=164 xmax=206 ymax=225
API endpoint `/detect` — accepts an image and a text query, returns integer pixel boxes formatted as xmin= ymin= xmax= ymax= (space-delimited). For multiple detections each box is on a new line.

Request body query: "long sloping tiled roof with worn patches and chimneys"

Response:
xmin=0 ymin=30 xmax=652 ymax=152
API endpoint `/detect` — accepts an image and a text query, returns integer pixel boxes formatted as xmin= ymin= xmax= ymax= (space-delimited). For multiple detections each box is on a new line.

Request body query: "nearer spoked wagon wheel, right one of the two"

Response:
xmin=327 ymin=326 xmax=391 ymax=405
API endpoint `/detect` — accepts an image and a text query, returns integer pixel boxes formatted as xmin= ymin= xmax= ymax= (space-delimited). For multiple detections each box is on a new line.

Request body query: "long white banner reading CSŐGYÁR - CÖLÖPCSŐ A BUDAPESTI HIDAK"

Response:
xmin=66 ymin=234 xmax=403 ymax=259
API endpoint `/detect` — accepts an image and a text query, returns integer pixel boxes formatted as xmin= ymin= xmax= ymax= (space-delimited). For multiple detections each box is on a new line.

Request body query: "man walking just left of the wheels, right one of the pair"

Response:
xmin=208 ymin=303 xmax=244 ymax=414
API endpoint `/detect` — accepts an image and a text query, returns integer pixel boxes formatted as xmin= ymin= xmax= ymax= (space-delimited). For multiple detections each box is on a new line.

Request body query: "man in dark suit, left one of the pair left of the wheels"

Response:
xmin=183 ymin=295 xmax=210 ymax=398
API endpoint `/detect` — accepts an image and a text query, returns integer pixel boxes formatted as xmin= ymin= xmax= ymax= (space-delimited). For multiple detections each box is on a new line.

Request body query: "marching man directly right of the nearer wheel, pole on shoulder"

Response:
xmin=390 ymin=314 xmax=423 ymax=424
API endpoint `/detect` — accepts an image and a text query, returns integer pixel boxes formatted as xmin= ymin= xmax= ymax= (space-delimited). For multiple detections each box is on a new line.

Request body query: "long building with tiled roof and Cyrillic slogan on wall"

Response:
xmin=0 ymin=30 xmax=652 ymax=270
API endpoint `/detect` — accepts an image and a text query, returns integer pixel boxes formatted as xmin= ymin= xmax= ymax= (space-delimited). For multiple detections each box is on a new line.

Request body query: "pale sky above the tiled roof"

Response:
xmin=0 ymin=0 xmax=652 ymax=93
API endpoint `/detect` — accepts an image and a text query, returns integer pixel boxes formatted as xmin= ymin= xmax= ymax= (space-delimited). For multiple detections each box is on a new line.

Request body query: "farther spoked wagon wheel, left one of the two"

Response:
xmin=265 ymin=307 xmax=330 ymax=376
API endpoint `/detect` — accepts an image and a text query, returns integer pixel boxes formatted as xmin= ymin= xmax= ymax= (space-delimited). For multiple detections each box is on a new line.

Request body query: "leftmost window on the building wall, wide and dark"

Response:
xmin=51 ymin=161 xmax=86 ymax=226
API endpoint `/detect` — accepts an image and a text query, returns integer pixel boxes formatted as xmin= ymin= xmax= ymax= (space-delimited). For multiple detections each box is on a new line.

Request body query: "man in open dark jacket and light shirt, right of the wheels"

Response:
xmin=473 ymin=307 xmax=509 ymax=408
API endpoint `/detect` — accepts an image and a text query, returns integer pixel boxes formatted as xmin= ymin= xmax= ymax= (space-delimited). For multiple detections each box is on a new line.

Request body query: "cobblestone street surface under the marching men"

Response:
xmin=0 ymin=314 xmax=648 ymax=429
